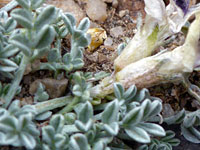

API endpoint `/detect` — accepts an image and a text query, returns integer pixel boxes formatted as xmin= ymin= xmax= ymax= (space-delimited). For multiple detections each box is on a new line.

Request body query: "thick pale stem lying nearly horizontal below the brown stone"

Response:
xmin=34 ymin=96 xmax=73 ymax=114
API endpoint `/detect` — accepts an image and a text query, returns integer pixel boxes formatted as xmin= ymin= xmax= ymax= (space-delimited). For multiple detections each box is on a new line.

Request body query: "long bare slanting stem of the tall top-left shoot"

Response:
xmin=3 ymin=55 xmax=29 ymax=108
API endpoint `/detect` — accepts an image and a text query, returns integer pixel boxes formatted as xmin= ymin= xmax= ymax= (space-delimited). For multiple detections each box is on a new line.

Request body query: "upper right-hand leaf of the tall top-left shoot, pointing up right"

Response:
xmin=35 ymin=6 xmax=58 ymax=31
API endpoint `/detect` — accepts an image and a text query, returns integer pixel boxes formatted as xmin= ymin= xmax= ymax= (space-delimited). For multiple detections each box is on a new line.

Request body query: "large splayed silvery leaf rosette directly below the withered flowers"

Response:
xmin=105 ymin=83 xmax=165 ymax=143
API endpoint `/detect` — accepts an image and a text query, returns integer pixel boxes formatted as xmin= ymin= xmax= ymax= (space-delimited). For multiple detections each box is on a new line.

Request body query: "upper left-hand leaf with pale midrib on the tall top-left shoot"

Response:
xmin=11 ymin=8 xmax=33 ymax=29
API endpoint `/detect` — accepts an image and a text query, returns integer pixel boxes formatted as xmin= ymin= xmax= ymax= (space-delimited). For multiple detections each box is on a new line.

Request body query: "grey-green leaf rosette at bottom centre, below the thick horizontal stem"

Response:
xmin=63 ymin=101 xmax=113 ymax=150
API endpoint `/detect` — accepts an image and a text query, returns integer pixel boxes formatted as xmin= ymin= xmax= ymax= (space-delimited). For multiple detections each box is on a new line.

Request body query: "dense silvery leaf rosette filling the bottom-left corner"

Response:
xmin=0 ymin=100 xmax=39 ymax=149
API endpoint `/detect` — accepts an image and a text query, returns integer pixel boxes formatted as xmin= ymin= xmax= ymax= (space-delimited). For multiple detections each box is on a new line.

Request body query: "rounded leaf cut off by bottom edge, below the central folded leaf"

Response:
xmin=69 ymin=133 xmax=89 ymax=150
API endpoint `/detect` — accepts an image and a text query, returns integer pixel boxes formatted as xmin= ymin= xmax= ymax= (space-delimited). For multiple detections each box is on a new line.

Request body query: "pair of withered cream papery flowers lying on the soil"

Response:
xmin=91 ymin=0 xmax=200 ymax=98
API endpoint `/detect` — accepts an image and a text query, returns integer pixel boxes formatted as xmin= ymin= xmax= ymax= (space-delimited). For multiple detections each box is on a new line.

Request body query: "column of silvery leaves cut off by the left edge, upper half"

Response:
xmin=0 ymin=11 xmax=19 ymax=78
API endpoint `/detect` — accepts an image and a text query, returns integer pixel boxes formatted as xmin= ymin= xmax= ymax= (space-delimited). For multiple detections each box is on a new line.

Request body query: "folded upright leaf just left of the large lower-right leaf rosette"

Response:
xmin=101 ymin=100 xmax=119 ymax=124
